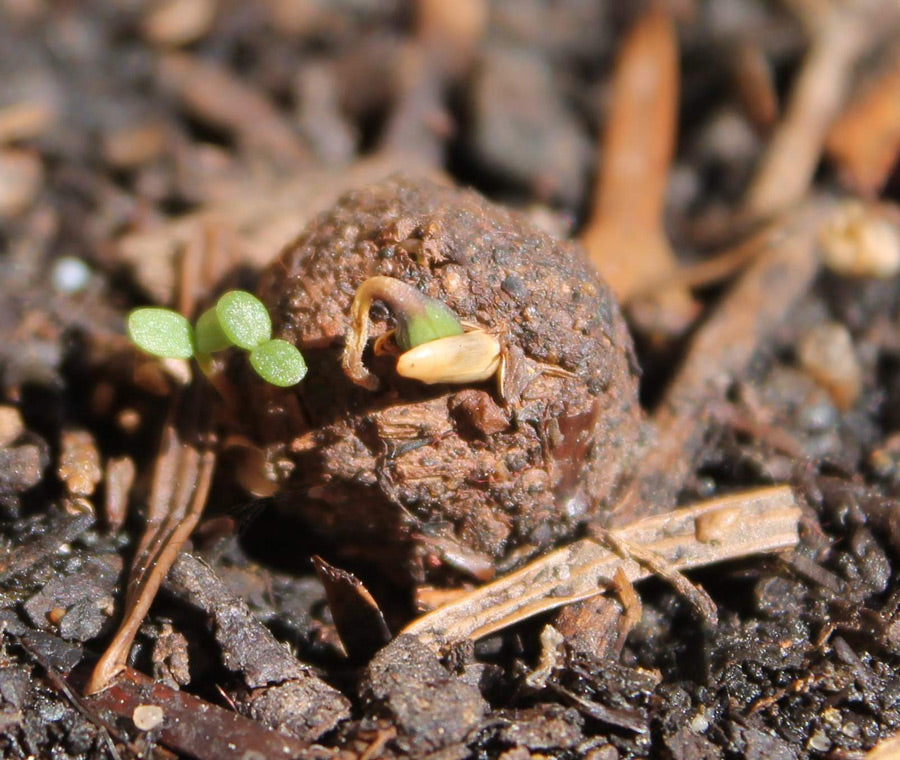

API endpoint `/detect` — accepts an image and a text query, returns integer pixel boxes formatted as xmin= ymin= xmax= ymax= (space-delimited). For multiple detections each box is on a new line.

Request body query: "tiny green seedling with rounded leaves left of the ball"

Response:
xmin=126 ymin=290 xmax=306 ymax=388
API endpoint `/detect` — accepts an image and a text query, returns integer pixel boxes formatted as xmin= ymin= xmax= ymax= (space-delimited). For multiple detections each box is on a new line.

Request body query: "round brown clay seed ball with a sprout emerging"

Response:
xmin=247 ymin=178 xmax=642 ymax=581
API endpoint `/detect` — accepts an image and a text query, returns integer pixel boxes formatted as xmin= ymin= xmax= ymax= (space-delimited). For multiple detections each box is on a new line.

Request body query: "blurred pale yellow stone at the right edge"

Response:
xmin=819 ymin=201 xmax=900 ymax=279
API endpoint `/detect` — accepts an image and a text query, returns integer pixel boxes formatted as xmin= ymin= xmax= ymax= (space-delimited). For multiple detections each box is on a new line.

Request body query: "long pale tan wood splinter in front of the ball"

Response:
xmin=403 ymin=486 xmax=800 ymax=648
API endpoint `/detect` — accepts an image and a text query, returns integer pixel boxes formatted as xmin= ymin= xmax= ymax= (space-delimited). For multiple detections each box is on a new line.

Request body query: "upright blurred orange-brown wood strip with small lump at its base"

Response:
xmin=581 ymin=4 xmax=697 ymax=334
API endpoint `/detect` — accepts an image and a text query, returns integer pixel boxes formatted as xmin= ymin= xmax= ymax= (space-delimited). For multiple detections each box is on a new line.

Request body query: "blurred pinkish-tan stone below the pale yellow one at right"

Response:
xmin=797 ymin=322 xmax=862 ymax=410
